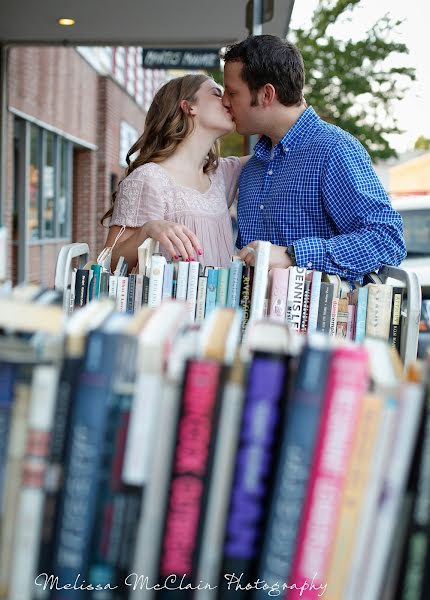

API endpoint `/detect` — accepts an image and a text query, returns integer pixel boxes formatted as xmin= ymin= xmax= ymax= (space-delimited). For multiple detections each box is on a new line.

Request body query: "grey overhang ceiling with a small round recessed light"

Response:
xmin=0 ymin=0 xmax=294 ymax=48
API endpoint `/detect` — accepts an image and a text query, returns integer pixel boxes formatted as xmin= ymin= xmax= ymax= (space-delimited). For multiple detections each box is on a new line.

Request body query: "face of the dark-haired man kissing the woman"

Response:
xmin=222 ymin=61 xmax=260 ymax=135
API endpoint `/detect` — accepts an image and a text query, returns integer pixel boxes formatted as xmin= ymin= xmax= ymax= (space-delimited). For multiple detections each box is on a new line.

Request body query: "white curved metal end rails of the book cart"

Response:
xmin=55 ymin=243 xmax=421 ymax=367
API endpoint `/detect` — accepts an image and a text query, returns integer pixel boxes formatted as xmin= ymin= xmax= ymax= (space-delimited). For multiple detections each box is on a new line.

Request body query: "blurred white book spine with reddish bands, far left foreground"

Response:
xmin=9 ymin=365 xmax=58 ymax=600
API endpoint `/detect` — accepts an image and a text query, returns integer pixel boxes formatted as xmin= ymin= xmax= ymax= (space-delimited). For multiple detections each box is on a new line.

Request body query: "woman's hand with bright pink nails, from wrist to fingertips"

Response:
xmin=142 ymin=220 xmax=203 ymax=260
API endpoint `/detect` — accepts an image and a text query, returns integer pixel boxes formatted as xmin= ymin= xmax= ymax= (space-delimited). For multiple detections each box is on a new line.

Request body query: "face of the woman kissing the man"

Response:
xmin=191 ymin=79 xmax=235 ymax=137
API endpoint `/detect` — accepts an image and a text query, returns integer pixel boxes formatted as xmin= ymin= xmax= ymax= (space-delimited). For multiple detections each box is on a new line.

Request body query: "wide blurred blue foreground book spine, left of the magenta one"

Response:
xmin=51 ymin=330 xmax=121 ymax=600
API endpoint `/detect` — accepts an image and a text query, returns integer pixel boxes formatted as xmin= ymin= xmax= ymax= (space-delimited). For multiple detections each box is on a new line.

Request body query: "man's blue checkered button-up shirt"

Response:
xmin=236 ymin=107 xmax=406 ymax=281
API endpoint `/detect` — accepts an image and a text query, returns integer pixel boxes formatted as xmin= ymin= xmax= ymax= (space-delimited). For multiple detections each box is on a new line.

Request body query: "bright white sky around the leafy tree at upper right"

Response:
xmin=290 ymin=0 xmax=430 ymax=152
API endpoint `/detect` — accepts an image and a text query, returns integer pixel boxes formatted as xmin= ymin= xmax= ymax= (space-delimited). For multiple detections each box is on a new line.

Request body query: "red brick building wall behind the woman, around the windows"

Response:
xmin=4 ymin=47 xmax=145 ymax=285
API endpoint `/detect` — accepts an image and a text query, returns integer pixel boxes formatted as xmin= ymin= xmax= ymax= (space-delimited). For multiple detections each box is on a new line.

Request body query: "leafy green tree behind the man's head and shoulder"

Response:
xmin=289 ymin=0 xmax=415 ymax=159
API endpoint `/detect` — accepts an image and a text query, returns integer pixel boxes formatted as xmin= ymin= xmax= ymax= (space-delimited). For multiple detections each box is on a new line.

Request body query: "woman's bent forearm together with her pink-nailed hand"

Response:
xmin=106 ymin=220 xmax=203 ymax=270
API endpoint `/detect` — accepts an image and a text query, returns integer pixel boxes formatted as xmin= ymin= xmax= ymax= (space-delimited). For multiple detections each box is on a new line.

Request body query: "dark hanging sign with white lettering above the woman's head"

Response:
xmin=142 ymin=48 xmax=220 ymax=71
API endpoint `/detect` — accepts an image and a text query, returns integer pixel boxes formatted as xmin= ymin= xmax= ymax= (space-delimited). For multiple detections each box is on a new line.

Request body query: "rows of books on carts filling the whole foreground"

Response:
xmin=0 ymin=240 xmax=430 ymax=600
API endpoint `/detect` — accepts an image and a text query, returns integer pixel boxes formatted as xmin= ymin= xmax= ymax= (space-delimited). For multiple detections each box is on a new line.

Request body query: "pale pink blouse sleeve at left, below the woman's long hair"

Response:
xmin=110 ymin=165 xmax=165 ymax=227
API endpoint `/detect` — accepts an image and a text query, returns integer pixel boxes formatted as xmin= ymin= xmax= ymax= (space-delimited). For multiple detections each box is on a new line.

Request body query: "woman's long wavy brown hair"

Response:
xmin=100 ymin=75 xmax=219 ymax=225
